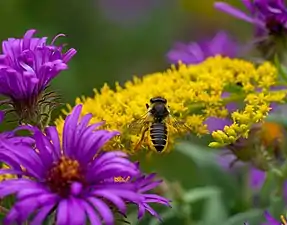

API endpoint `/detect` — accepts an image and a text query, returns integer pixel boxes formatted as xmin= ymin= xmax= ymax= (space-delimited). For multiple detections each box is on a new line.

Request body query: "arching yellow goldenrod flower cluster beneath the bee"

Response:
xmin=56 ymin=56 xmax=285 ymax=153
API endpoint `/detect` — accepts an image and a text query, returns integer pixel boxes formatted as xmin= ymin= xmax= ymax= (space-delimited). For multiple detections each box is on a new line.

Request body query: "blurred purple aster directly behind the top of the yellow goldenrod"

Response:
xmin=167 ymin=31 xmax=239 ymax=64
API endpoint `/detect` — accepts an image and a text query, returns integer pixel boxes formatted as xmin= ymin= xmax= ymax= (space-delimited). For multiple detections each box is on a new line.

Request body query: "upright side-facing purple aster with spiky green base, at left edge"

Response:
xmin=0 ymin=30 xmax=76 ymax=125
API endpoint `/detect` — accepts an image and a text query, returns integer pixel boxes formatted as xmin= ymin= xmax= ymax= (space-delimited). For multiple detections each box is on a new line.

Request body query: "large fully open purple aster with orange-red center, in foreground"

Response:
xmin=0 ymin=105 xmax=170 ymax=225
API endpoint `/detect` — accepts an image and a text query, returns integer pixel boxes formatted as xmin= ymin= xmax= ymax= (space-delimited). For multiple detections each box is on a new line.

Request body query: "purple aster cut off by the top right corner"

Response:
xmin=215 ymin=0 xmax=287 ymax=58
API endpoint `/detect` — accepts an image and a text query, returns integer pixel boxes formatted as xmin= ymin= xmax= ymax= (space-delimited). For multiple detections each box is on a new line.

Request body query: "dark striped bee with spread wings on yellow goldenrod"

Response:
xmin=128 ymin=96 xmax=190 ymax=153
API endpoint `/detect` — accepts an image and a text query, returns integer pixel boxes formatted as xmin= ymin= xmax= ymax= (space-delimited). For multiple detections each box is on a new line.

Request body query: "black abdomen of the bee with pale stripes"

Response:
xmin=150 ymin=123 xmax=167 ymax=152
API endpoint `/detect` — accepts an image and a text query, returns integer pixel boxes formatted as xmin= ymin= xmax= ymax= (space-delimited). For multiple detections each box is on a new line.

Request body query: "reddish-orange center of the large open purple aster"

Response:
xmin=46 ymin=157 xmax=84 ymax=197
